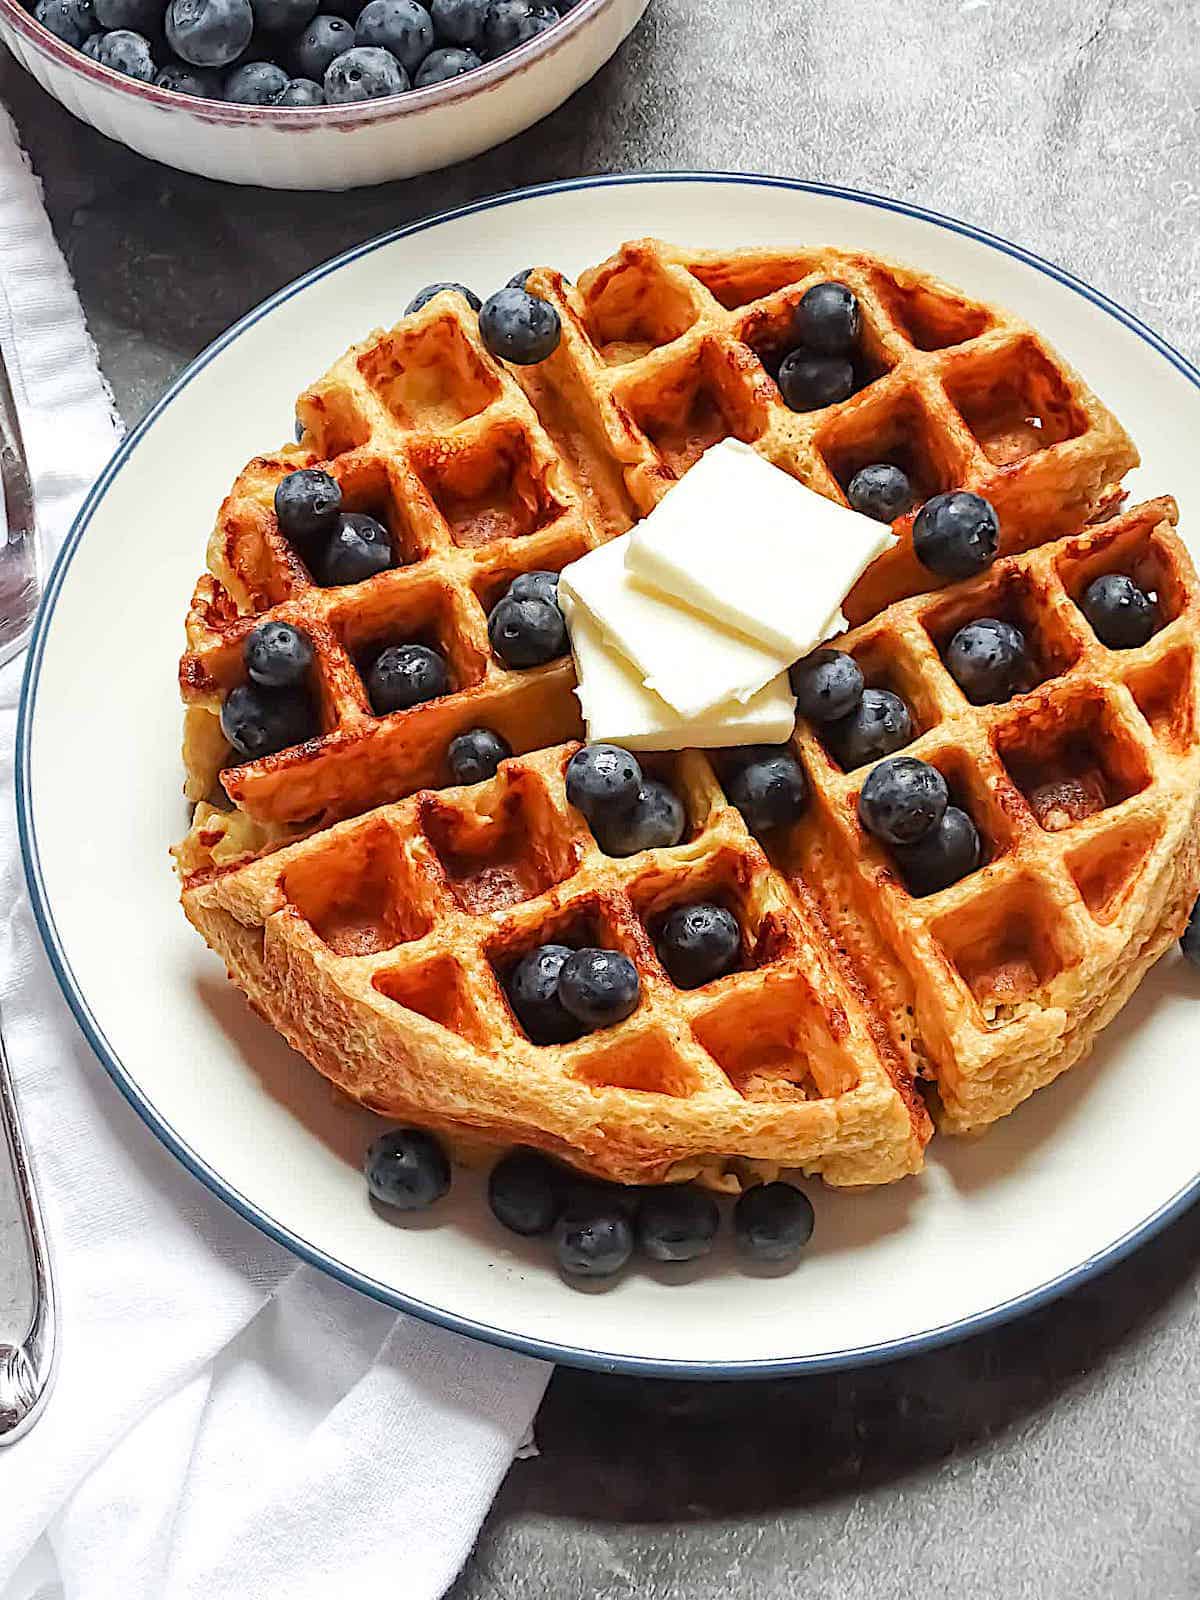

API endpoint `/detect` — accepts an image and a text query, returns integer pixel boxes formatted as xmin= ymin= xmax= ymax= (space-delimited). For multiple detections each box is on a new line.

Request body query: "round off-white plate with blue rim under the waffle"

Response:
xmin=19 ymin=176 xmax=1200 ymax=1378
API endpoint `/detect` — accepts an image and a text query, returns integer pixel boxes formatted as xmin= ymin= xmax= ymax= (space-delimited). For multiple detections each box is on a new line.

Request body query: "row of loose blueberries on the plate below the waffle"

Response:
xmin=365 ymin=1128 xmax=813 ymax=1278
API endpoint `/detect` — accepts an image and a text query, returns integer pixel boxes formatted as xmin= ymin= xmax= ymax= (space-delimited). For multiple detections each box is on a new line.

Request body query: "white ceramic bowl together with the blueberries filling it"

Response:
xmin=0 ymin=0 xmax=648 ymax=189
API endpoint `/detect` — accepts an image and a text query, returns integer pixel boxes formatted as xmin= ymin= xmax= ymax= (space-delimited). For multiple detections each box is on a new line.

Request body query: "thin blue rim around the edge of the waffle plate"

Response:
xmin=14 ymin=171 xmax=1200 ymax=1379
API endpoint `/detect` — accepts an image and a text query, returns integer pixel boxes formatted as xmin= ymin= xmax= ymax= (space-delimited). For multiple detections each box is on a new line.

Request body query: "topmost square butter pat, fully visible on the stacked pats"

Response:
xmin=626 ymin=438 xmax=896 ymax=662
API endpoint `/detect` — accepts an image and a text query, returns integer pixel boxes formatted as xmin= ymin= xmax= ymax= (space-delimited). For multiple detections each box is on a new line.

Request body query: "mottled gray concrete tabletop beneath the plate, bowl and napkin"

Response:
xmin=0 ymin=0 xmax=1200 ymax=1600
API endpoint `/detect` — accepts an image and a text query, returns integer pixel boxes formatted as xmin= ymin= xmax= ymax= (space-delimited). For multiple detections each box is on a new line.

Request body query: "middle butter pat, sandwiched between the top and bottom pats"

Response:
xmin=558 ymin=528 xmax=784 ymax=722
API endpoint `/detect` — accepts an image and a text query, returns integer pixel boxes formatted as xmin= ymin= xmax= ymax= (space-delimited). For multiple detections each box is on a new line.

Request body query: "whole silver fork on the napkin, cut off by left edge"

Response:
xmin=0 ymin=350 xmax=58 ymax=1445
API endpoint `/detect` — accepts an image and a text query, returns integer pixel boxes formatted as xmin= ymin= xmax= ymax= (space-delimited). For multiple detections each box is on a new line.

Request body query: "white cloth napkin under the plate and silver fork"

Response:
xmin=0 ymin=110 xmax=550 ymax=1600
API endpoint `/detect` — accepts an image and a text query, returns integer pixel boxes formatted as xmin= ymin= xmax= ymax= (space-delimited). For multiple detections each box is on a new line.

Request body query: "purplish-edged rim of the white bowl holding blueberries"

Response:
xmin=0 ymin=0 xmax=624 ymax=128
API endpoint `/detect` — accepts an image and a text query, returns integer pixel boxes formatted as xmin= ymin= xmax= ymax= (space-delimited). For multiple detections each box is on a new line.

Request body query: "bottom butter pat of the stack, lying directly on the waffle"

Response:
xmin=560 ymin=590 xmax=795 ymax=750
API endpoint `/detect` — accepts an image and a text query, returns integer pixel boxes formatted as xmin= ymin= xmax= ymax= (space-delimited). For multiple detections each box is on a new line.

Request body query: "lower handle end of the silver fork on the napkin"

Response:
xmin=0 ymin=1019 xmax=58 ymax=1445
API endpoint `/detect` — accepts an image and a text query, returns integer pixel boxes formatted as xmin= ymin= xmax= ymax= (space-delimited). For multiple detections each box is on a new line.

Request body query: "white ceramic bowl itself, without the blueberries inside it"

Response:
xmin=0 ymin=0 xmax=650 ymax=189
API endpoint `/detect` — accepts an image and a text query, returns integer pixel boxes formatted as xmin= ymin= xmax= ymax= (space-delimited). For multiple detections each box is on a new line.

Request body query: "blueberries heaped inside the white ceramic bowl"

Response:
xmin=30 ymin=0 xmax=578 ymax=106
